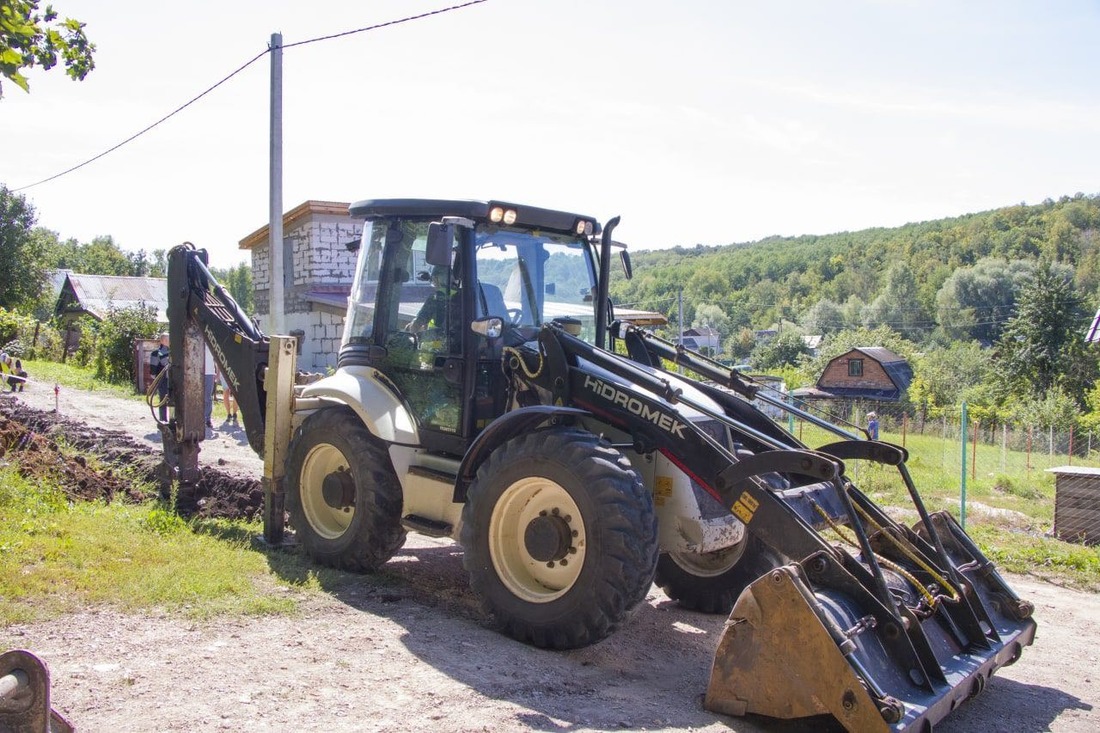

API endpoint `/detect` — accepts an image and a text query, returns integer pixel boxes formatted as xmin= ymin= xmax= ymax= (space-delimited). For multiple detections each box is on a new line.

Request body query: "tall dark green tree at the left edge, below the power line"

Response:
xmin=0 ymin=184 xmax=45 ymax=308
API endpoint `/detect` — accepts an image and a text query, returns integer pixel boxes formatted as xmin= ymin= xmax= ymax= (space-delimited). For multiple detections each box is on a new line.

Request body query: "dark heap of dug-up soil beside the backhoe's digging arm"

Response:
xmin=0 ymin=397 xmax=263 ymax=519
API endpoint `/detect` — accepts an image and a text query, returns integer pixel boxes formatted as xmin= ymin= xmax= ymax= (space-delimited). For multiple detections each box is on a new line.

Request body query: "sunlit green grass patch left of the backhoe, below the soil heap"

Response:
xmin=0 ymin=467 xmax=314 ymax=625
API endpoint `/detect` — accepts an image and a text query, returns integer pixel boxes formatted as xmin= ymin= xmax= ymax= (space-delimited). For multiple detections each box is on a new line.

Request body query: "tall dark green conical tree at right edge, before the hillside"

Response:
xmin=997 ymin=264 xmax=1097 ymax=406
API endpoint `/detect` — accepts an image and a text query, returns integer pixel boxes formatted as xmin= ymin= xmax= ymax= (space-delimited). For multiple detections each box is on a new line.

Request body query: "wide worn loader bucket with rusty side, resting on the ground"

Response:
xmin=704 ymin=514 xmax=1035 ymax=732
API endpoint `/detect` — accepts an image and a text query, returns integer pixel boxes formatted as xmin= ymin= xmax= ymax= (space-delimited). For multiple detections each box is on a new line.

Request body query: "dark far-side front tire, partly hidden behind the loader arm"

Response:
xmin=655 ymin=536 xmax=782 ymax=613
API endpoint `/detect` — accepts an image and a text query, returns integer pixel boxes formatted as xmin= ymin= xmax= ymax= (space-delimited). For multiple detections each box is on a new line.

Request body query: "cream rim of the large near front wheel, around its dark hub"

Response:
xmin=488 ymin=477 xmax=587 ymax=603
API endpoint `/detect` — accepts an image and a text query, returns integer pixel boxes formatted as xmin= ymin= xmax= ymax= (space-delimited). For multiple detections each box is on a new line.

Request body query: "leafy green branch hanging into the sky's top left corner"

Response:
xmin=0 ymin=0 xmax=96 ymax=98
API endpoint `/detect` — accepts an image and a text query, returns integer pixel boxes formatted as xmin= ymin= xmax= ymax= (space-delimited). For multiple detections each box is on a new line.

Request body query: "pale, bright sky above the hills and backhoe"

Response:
xmin=0 ymin=0 xmax=1100 ymax=266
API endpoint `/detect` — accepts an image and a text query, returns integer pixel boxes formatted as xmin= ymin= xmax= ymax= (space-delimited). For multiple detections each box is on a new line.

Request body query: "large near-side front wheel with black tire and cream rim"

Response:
xmin=462 ymin=428 xmax=658 ymax=649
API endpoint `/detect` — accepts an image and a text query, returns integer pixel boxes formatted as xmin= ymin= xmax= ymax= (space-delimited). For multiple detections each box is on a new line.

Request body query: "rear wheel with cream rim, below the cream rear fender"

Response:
xmin=286 ymin=407 xmax=405 ymax=572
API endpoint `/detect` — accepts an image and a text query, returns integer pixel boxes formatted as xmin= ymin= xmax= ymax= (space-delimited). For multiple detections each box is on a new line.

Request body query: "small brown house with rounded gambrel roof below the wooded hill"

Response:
xmin=793 ymin=347 xmax=913 ymax=402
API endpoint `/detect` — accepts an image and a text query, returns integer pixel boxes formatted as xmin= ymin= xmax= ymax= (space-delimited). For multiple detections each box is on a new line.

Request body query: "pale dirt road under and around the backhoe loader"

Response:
xmin=0 ymin=390 xmax=1100 ymax=733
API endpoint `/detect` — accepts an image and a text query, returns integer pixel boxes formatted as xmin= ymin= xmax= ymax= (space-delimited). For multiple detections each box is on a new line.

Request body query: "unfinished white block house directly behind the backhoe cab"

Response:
xmin=240 ymin=200 xmax=668 ymax=371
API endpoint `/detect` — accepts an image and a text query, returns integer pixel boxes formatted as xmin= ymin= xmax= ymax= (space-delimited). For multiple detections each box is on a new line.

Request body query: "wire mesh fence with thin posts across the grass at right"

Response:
xmin=748 ymin=387 xmax=1100 ymax=544
